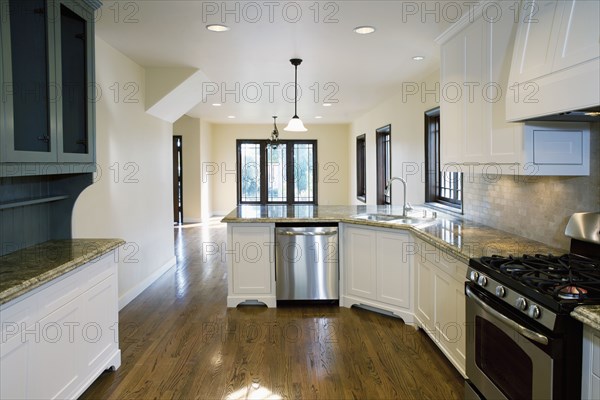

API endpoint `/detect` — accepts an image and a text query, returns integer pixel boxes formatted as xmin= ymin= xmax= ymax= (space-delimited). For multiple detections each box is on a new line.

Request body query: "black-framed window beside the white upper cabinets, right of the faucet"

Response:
xmin=425 ymin=107 xmax=463 ymax=210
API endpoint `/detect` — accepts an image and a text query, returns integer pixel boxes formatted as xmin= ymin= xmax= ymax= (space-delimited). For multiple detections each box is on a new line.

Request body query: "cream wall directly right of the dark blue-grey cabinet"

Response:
xmin=73 ymin=37 xmax=175 ymax=307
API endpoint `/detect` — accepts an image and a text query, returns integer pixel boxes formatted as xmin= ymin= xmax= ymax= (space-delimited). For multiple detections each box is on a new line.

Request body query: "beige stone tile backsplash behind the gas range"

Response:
xmin=463 ymin=123 xmax=600 ymax=250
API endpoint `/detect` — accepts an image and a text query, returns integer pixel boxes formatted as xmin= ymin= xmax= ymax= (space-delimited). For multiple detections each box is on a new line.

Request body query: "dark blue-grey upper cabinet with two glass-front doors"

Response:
xmin=0 ymin=0 xmax=100 ymax=176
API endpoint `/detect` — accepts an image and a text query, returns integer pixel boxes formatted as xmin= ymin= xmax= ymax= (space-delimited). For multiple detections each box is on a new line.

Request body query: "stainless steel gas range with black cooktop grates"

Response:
xmin=465 ymin=213 xmax=600 ymax=400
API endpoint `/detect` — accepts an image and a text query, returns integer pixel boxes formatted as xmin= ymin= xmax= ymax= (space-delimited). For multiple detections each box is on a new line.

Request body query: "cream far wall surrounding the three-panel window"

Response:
xmin=210 ymin=124 xmax=349 ymax=215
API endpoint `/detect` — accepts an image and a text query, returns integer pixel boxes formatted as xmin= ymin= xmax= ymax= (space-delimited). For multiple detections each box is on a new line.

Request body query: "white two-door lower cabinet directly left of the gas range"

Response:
xmin=414 ymin=239 xmax=467 ymax=377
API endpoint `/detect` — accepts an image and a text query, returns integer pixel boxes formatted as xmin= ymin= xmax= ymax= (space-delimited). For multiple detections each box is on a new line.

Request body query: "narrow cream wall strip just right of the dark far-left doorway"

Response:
xmin=173 ymin=115 xmax=202 ymax=222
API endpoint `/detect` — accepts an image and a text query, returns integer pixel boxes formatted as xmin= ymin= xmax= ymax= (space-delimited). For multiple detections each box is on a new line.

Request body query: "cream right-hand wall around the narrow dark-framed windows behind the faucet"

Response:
xmin=347 ymin=71 xmax=439 ymax=205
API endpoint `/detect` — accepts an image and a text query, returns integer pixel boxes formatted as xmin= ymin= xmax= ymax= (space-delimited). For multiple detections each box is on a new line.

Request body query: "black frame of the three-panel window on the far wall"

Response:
xmin=236 ymin=139 xmax=319 ymax=205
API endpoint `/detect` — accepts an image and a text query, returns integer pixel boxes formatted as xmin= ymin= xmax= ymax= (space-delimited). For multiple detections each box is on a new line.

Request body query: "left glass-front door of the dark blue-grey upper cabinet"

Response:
xmin=0 ymin=0 xmax=57 ymax=162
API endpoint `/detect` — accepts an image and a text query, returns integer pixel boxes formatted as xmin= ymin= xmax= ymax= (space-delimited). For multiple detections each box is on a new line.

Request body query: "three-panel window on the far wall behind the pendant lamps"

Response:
xmin=237 ymin=140 xmax=317 ymax=204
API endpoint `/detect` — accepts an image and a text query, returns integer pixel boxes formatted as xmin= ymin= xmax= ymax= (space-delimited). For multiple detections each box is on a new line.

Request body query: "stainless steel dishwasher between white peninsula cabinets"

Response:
xmin=275 ymin=226 xmax=339 ymax=300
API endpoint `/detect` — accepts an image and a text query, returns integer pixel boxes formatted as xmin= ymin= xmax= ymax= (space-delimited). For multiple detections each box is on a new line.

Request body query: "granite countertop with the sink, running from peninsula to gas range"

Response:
xmin=222 ymin=205 xmax=568 ymax=262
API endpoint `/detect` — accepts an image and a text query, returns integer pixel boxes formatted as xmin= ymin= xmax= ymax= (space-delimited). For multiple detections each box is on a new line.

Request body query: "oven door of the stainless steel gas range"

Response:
xmin=465 ymin=283 xmax=553 ymax=400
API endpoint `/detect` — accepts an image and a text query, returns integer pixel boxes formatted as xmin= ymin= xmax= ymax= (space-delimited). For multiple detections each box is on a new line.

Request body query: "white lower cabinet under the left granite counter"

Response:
xmin=0 ymin=252 xmax=121 ymax=399
